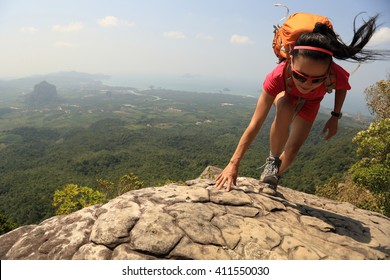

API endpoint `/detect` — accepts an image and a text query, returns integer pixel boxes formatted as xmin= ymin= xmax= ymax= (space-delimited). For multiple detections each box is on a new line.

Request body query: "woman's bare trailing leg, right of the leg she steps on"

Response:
xmin=279 ymin=115 xmax=313 ymax=174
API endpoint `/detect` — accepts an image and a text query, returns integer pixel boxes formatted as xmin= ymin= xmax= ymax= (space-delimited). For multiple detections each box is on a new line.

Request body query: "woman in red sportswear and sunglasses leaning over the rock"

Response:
xmin=215 ymin=16 xmax=388 ymax=195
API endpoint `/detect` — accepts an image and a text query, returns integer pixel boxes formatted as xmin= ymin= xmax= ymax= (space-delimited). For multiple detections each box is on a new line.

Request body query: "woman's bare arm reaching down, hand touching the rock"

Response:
xmin=215 ymin=90 xmax=275 ymax=191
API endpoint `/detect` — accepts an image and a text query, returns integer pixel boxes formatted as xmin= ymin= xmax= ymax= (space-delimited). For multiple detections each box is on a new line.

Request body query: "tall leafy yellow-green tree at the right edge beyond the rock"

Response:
xmin=349 ymin=74 xmax=390 ymax=216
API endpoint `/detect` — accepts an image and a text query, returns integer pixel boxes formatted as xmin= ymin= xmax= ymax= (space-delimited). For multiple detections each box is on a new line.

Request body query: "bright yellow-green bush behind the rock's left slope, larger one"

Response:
xmin=52 ymin=184 xmax=106 ymax=215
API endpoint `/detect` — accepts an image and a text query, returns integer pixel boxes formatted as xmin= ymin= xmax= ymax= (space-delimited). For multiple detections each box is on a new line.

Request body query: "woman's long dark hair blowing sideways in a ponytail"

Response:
xmin=291 ymin=14 xmax=390 ymax=62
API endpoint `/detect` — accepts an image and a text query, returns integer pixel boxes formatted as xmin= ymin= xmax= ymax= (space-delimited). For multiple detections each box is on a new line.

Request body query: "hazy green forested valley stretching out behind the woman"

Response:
xmin=0 ymin=82 xmax=368 ymax=228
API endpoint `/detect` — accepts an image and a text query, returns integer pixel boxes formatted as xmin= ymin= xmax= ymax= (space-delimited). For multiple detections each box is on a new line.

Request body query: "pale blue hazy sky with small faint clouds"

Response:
xmin=0 ymin=0 xmax=390 ymax=112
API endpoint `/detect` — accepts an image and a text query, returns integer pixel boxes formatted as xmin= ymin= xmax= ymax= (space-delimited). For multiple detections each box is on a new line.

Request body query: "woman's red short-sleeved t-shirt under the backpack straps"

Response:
xmin=263 ymin=61 xmax=351 ymax=100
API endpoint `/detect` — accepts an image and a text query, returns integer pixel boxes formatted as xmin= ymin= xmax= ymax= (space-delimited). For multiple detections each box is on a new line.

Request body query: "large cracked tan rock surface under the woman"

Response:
xmin=0 ymin=167 xmax=390 ymax=260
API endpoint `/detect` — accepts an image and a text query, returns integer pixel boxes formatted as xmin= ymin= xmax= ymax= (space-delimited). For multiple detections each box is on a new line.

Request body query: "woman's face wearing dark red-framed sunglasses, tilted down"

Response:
xmin=291 ymin=55 xmax=329 ymax=94
